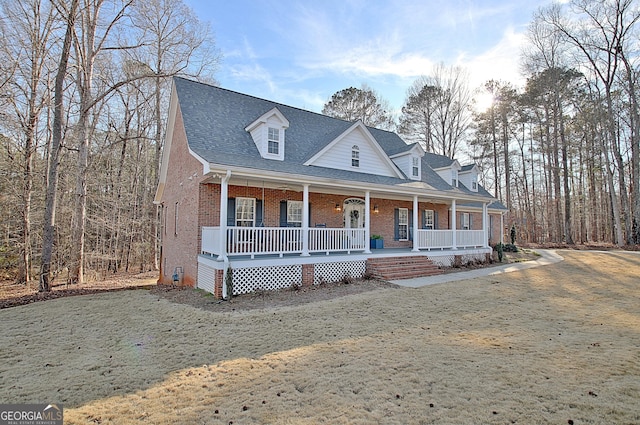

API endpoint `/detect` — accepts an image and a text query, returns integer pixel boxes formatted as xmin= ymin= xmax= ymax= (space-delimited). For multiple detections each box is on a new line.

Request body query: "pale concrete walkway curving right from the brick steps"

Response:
xmin=391 ymin=249 xmax=564 ymax=288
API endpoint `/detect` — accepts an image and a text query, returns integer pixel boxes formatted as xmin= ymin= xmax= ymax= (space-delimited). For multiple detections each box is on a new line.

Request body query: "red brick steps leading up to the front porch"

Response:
xmin=367 ymin=256 xmax=443 ymax=280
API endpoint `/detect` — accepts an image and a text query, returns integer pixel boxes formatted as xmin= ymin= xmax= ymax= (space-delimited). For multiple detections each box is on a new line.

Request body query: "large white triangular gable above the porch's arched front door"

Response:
xmin=304 ymin=121 xmax=403 ymax=178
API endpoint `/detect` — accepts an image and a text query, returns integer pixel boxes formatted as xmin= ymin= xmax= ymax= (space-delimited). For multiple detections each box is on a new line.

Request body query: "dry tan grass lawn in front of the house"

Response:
xmin=0 ymin=251 xmax=640 ymax=424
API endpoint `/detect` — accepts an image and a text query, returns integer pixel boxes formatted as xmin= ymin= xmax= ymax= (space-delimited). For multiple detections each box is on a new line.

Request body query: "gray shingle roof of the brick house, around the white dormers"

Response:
xmin=174 ymin=77 xmax=496 ymax=199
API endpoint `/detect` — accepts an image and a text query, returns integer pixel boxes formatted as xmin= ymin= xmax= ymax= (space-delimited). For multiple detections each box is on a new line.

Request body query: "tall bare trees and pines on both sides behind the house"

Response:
xmin=0 ymin=0 xmax=640 ymax=291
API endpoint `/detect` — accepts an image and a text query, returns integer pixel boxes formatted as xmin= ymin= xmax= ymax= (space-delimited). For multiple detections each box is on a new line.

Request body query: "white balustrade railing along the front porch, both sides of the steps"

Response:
xmin=202 ymin=227 xmax=486 ymax=258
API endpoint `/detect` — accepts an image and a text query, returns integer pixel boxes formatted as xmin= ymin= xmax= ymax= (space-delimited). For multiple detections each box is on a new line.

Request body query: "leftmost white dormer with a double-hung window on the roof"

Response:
xmin=245 ymin=108 xmax=289 ymax=161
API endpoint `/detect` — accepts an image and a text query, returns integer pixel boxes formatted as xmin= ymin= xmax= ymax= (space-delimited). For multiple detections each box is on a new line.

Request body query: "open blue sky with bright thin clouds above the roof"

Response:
xmin=185 ymin=0 xmax=550 ymax=113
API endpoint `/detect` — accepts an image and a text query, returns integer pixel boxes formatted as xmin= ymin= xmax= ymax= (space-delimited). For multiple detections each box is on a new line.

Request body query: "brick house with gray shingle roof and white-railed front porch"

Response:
xmin=154 ymin=78 xmax=505 ymax=297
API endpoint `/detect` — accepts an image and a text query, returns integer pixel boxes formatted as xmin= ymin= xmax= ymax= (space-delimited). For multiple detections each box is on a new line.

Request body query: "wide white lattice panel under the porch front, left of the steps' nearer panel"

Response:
xmin=233 ymin=264 xmax=302 ymax=295
